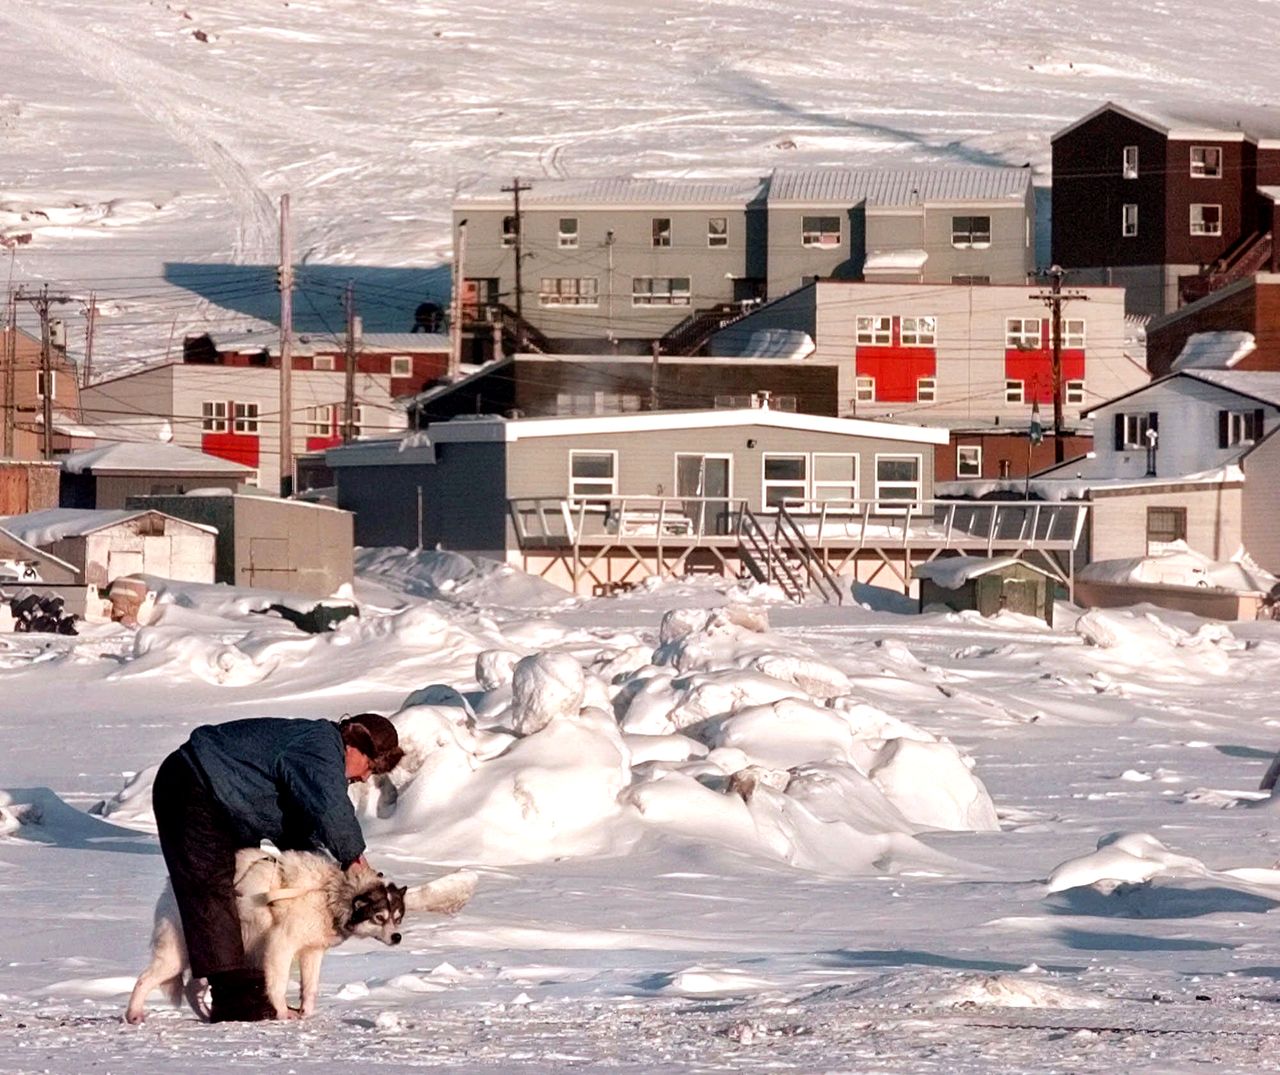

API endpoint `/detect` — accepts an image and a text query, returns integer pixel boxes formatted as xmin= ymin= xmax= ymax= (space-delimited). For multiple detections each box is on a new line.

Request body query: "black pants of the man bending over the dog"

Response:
xmin=151 ymin=753 xmax=244 ymax=978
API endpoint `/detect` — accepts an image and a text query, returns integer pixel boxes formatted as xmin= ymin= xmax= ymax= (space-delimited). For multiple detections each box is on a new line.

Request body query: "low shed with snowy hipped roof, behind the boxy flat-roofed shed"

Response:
xmin=60 ymin=440 xmax=257 ymax=508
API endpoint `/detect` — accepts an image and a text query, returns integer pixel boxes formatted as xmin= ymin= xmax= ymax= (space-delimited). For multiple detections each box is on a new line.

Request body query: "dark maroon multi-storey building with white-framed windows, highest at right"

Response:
xmin=1052 ymin=101 xmax=1280 ymax=315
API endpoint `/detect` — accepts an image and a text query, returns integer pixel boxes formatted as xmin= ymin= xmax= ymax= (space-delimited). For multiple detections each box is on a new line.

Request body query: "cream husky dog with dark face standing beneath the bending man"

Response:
xmin=124 ymin=848 xmax=476 ymax=1023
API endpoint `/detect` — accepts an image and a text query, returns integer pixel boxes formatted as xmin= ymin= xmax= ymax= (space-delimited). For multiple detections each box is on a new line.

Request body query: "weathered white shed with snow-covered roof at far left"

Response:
xmin=0 ymin=508 xmax=218 ymax=590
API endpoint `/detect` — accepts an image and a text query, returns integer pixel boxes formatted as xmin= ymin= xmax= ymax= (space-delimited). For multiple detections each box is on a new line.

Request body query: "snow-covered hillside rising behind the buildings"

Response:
xmin=0 ymin=0 xmax=1280 ymax=372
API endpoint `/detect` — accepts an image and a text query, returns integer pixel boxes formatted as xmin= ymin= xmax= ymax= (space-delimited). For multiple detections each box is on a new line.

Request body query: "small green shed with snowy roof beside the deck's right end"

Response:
xmin=913 ymin=557 xmax=1057 ymax=627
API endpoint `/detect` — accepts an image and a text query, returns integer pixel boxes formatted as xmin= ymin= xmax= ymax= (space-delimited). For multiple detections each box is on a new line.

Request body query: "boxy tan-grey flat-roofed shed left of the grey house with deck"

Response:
xmin=128 ymin=491 xmax=355 ymax=598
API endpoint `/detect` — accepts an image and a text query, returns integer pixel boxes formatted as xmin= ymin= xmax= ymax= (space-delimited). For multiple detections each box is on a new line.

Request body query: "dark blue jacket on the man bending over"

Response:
xmin=179 ymin=717 xmax=365 ymax=866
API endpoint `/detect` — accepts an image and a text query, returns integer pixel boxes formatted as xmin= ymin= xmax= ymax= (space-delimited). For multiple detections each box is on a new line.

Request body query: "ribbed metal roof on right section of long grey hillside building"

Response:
xmin=769 ymin=165 xmax=1032 ymax=207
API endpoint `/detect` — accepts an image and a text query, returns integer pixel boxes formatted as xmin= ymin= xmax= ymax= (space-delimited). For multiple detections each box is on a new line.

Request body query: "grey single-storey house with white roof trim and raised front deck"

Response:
xmin=326 ymin=408 xmax=1079 ymax=599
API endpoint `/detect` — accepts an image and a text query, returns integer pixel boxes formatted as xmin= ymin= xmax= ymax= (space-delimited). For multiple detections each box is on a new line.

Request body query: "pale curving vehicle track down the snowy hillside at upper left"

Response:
xmin=0 ymin=0 xmax=278 ymax=265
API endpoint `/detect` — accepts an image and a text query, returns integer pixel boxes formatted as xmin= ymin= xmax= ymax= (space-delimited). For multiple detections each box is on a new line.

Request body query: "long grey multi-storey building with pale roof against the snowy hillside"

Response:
xmin=453 ymin=168 xmax=1036 ymax=352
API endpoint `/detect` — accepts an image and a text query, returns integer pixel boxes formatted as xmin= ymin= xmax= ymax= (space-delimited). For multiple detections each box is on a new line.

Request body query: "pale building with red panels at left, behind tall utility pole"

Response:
xmin=82 ymin=362 xmax=404 ymax=491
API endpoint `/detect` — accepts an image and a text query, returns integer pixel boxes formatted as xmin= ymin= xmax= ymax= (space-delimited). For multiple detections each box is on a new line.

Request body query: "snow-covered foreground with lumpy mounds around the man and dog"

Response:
xmin=0 ymin=550 xmax=1280 ymax=1075
